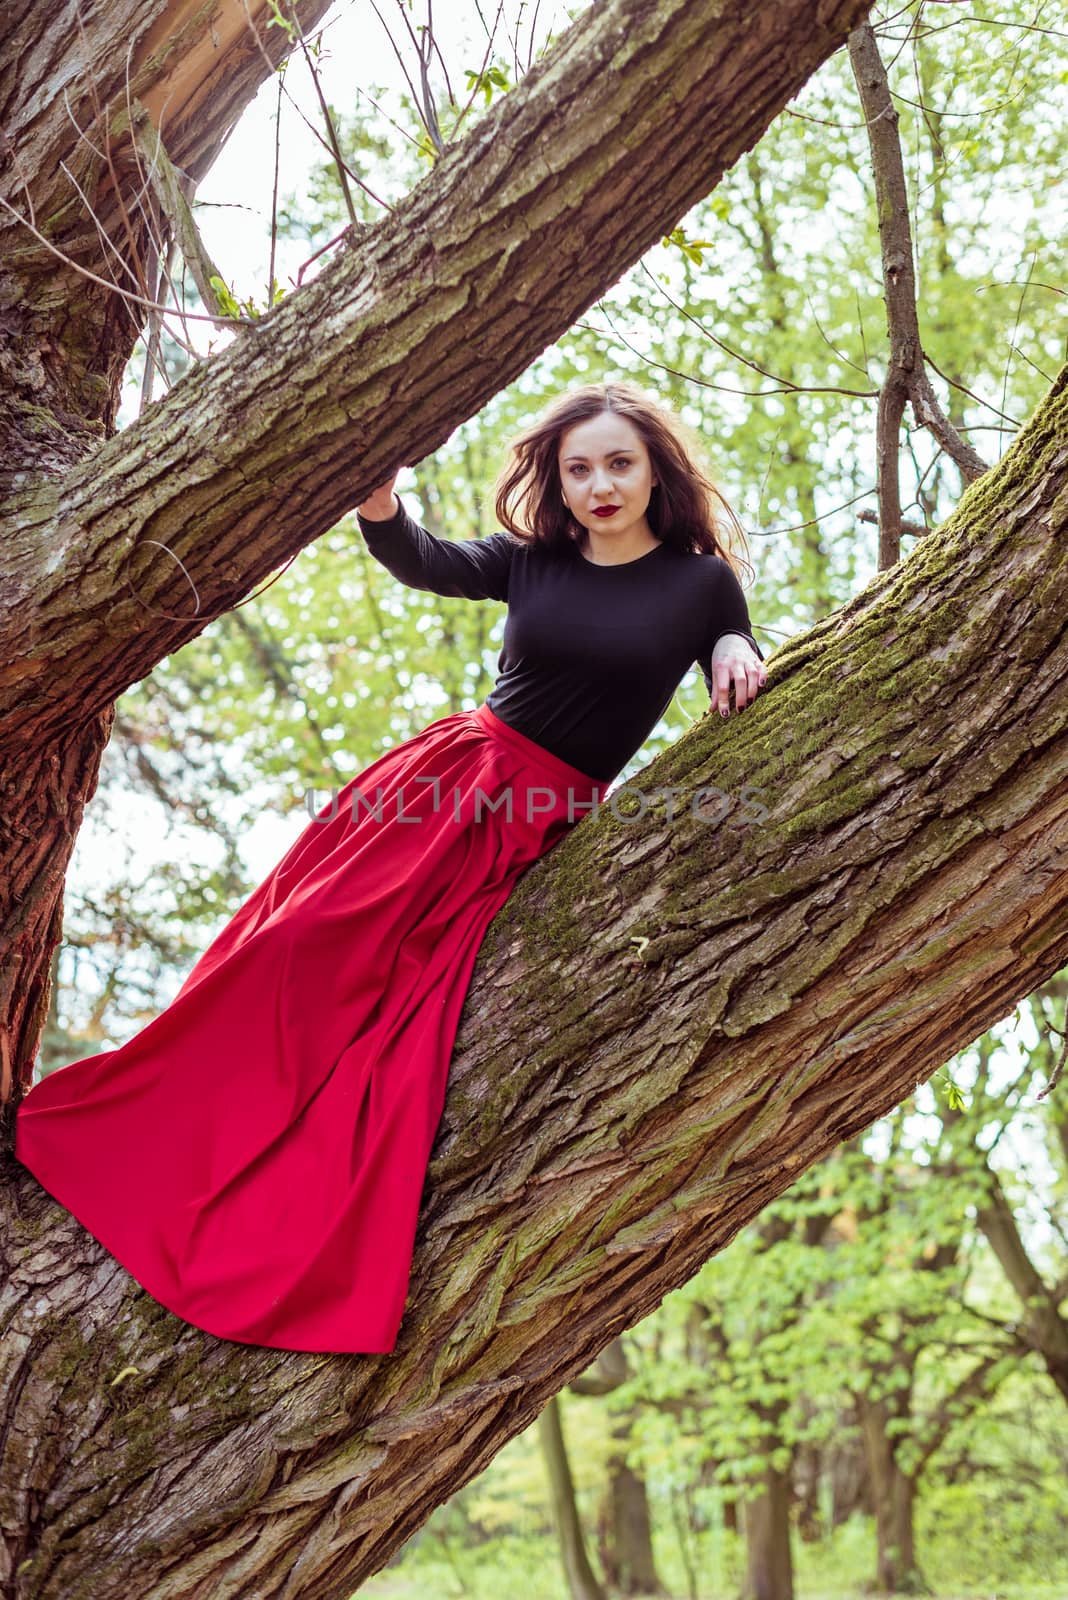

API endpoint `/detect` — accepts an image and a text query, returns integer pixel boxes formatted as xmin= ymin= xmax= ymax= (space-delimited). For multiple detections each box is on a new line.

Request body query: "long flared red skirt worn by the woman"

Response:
xmin=14 ymin=706 xmax=608 ymax=1352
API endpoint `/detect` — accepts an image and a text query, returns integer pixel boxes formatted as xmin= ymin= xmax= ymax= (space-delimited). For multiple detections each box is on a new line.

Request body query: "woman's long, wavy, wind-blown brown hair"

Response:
xmin=494 ymin=378 xmax=753 ymax=579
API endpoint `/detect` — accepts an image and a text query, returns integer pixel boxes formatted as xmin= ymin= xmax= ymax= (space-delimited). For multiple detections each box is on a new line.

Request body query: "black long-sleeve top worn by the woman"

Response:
xmin=358 ymin=496 xmax=763 ymax=782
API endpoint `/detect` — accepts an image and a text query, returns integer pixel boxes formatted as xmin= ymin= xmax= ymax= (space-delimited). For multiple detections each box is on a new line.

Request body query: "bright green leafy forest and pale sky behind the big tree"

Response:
xmin=40 ymin=0 xmax=1068 ymax=1600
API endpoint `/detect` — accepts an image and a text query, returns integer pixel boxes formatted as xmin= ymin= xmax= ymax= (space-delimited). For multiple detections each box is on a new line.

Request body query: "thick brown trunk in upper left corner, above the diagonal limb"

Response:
xmin=0 ymin=0 xmax=337 ymax=467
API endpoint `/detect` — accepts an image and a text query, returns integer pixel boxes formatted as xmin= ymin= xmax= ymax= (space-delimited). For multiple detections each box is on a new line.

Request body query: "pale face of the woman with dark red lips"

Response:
xmin=556 ymin=411 xmax=657 ymax=538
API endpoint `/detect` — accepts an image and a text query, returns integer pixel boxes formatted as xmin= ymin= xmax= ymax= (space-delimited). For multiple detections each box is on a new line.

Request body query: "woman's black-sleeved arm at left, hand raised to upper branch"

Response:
xmin=357 ymin=488 xmax=518 ymax=600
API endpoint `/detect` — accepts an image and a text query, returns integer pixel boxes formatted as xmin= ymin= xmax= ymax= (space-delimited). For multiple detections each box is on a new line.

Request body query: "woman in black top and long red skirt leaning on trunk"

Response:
xmin=16 ymin=382 xmax=766 ymax=1352
